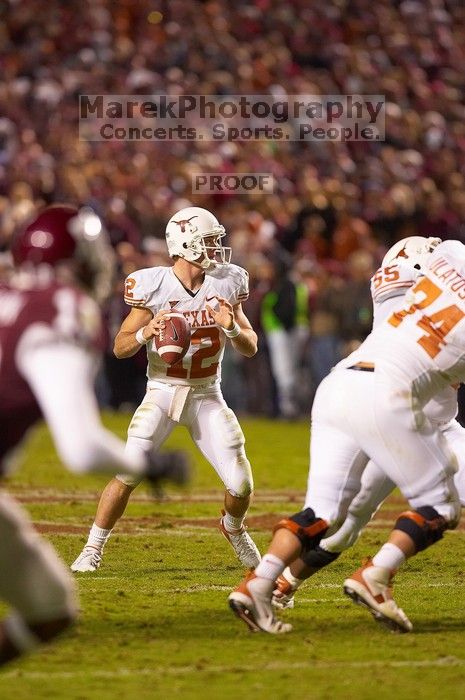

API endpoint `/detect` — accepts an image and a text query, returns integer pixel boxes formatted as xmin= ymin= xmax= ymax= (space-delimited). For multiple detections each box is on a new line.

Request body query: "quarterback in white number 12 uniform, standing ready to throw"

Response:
xmin=71 ymin=207 xmax=260 ymax=572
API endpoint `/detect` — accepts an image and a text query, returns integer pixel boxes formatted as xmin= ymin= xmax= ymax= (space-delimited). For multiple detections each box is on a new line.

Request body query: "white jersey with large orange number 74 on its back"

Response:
xmin=338 ymin=241 xmax=465 ymax=405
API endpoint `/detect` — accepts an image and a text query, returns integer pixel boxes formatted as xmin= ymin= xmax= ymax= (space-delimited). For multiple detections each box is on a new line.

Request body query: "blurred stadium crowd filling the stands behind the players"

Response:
xmin=0 ymin=0 xmax=465 ymax=417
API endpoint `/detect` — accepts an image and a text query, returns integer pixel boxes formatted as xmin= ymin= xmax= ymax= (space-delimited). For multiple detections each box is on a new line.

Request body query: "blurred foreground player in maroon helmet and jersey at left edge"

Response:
xmin=0 ymin=205 xmax=187 ymax=665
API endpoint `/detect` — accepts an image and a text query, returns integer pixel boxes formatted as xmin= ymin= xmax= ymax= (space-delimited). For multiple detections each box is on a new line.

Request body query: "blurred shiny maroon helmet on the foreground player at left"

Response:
xmin=11 ymin=204 xmax=115 ymax=301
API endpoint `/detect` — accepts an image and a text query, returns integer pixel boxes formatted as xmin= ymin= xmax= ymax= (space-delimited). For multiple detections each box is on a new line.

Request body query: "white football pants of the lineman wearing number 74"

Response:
xmin=305 ymin=368 xmax=460 ymax=535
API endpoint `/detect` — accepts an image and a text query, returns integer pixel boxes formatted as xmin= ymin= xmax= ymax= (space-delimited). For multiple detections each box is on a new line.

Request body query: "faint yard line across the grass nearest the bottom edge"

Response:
xmin=0 ymin=656 xmax=465 ymax=685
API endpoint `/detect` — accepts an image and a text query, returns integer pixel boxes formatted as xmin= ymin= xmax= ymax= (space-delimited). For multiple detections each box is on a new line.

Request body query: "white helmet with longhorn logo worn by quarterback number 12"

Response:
xmin=166 ymin=207 xmax=232 ymax=270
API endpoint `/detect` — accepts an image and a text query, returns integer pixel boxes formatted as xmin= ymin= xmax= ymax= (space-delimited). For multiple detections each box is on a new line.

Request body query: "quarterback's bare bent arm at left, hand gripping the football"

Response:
xmin=113 ymin=307 xmax=169 ymax=360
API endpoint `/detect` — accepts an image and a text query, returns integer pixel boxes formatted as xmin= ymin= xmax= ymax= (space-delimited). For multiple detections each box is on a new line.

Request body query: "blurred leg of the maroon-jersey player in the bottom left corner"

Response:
xmin=0 ymin=493 xmax=77 ymax=665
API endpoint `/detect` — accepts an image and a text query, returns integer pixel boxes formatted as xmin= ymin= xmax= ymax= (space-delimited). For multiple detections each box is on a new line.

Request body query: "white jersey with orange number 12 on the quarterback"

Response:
xmin=124 ymin=265 xmax=249 ymax=386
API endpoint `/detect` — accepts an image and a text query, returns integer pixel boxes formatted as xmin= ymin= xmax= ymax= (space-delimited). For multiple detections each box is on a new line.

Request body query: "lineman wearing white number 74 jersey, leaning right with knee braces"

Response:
xmin=229 ymin=241 xmax=465 ymax=634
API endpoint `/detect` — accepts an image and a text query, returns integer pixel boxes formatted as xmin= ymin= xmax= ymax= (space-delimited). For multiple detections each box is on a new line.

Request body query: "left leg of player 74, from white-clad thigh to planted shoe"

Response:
xmin=229 ymin=378 xmax=367 ymax=633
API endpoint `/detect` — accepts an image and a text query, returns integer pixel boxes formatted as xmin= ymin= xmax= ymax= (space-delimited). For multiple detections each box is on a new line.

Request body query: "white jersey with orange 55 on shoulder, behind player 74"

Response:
xmin=370 ymin=260 xmax=458 ymax=425
